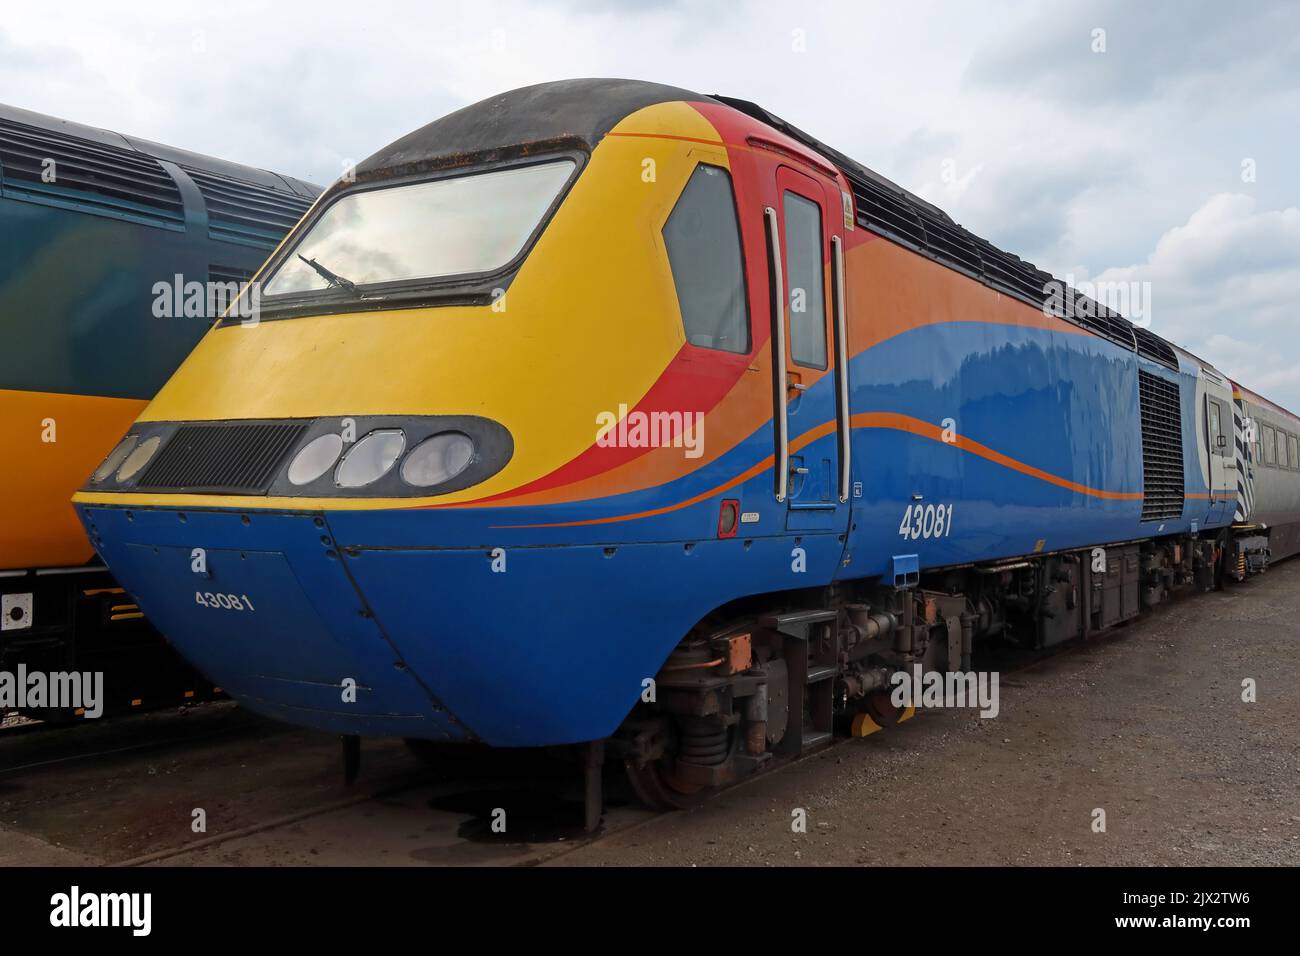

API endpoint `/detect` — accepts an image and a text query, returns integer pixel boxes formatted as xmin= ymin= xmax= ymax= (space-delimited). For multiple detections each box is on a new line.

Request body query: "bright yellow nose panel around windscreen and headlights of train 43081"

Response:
xmin=81 ymin=103 xmax=743 ymax=509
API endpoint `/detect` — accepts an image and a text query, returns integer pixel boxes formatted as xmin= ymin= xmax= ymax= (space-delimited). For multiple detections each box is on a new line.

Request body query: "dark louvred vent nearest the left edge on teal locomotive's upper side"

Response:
xmin=0 ymin=120 xmax=185 ymax=228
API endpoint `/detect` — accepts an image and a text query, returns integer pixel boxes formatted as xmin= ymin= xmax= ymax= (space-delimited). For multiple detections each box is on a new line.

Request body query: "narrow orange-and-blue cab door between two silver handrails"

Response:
xmin=764 ymin=166 xmax=849 ymax=531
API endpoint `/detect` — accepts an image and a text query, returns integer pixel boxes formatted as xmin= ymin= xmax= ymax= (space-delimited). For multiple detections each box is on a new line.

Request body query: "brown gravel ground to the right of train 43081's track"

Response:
xmin=556 ymin=561 xmax=1300 ymax=866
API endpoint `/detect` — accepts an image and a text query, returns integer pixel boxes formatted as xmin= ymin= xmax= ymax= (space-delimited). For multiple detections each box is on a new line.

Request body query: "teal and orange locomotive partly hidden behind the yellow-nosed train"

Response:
xmin=0 ymin=105 xmax=320 ymax=717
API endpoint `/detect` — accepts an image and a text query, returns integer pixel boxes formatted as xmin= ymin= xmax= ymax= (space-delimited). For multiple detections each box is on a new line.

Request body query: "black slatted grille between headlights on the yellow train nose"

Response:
xmin=137 ymin=421 xmax=307 ymax=494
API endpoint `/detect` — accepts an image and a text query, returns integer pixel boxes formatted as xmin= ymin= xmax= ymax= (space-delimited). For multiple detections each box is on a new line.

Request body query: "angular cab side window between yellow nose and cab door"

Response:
xmin=663 ymin=164 xmax=749 ymax=354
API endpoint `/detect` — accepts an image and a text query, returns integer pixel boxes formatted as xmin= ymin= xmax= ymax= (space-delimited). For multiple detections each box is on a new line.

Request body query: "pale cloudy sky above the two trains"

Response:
xmin=0 ymin=0 xmax=1300 ymax=410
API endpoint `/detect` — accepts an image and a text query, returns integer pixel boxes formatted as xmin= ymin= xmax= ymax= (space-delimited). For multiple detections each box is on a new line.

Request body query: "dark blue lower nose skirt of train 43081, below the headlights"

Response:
xmin=81 ymin=506 xmax=844 ymax=747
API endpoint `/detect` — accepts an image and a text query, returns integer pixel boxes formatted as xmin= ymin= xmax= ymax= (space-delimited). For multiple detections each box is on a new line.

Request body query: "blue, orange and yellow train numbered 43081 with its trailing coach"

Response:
xmin=75 ymin=79 xmax=1300 ymax=806
